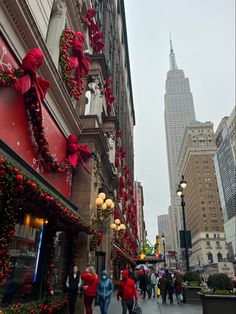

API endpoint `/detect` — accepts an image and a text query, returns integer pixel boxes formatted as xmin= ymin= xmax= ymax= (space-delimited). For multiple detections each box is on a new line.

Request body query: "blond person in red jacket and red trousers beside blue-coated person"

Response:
xmin=81 ymin=266 xmax=98 ymax=314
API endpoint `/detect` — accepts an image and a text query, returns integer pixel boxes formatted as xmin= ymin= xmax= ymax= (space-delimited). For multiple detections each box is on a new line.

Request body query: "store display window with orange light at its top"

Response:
xmin=2 ymin=214 xmax=47 ymax=306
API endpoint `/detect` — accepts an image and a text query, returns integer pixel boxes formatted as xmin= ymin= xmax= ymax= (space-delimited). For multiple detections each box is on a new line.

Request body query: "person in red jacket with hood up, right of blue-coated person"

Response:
xmin=117 ymin=270 xmax=138 ymax=314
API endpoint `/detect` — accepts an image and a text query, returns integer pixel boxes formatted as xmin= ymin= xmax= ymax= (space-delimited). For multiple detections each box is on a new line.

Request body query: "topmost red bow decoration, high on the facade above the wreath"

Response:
xmin=81 ymin=8 xmax=104 ymax=53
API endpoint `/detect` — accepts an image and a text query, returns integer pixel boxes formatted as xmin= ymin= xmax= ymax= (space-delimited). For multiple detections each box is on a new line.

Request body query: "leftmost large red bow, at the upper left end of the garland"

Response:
xmin=14 ymin=48 xmax=49 ymax=116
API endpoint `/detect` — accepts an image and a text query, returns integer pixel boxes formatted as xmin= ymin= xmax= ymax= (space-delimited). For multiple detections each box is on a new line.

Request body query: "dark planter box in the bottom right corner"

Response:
xmin=199 ymin=293 xmax=236 ymax=314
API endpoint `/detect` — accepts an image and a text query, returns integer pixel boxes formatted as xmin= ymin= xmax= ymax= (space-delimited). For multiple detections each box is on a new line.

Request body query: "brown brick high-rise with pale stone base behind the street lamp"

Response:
xmin=177 ymin=121 xmax=228 ymax=267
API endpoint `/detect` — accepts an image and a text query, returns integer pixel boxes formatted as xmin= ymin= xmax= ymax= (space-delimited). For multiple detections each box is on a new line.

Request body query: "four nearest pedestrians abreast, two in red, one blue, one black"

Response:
xmin=66 ymin=266 xmax=141 ymax=314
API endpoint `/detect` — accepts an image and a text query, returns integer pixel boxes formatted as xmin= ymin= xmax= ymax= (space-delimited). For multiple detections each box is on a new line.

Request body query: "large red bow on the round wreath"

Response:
xmin=69 ymin=32 xmax=89 ymax=93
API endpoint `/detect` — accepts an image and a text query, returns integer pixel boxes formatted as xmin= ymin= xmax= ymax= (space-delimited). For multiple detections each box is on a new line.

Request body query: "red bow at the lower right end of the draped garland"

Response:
xmin=67 ymin=134 xmax=91 ymax=174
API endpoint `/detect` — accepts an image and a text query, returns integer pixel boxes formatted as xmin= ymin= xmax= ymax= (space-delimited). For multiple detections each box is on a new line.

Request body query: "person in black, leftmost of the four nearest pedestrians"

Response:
xmin=66 ymin=266 xmax=81 ymax=314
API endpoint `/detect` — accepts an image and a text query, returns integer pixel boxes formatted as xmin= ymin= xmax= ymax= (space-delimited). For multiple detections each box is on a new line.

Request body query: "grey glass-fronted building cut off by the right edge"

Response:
xmin=214 ymin=108 xmax=236 ymax=260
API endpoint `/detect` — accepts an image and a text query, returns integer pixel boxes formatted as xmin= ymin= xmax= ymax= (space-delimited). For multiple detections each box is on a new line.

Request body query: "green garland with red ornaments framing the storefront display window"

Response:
xmin=0 ymin=156 xmax=96 ymax=295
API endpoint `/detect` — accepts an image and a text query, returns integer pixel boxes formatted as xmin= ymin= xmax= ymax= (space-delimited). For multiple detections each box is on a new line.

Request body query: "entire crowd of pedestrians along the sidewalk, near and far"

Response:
xmin=66 ymin=266 xmax=183 ymax=314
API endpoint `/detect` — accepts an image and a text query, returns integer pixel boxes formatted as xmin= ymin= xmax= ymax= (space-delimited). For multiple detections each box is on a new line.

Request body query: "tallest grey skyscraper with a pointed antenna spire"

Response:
xmin=165 ymin=40 xmax=196 ymax=250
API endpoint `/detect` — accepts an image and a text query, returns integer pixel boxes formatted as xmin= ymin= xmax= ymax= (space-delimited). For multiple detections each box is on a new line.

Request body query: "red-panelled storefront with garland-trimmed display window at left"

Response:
xmin=0 ymin=19 xmax=95 ymax=310
